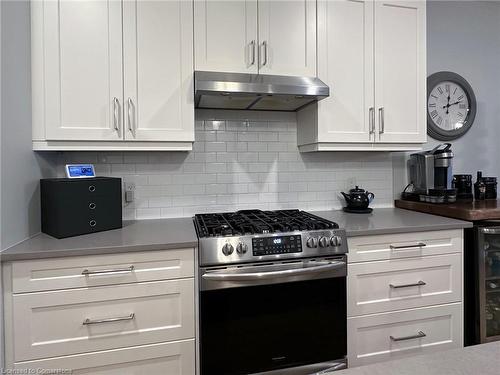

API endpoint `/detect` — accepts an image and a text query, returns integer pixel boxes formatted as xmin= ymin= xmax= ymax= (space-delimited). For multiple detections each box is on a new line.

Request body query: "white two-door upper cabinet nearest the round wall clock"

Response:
xmin=297 ymin=0 xmax=426 ymax=151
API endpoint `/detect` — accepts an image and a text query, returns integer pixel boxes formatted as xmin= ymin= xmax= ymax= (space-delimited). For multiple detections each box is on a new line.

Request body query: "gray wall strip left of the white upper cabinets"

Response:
xmin=0 ymin=1 xmax=54 ymax=253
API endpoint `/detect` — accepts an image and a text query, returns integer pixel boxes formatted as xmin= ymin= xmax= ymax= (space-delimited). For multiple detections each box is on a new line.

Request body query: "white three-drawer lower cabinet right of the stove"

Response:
xmin=347 ymin=230 xmax=463 ymax=367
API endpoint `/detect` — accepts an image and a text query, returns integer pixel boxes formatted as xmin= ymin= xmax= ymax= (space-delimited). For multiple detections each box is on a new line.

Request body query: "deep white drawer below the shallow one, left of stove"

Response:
xmin=12 ymin=278 xmax=195 ymax=362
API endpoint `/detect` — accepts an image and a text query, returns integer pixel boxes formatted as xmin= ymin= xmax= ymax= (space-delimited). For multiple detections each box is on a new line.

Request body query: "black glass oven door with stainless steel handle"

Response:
xmin=200 ymin=256 xmax=347 ymax=375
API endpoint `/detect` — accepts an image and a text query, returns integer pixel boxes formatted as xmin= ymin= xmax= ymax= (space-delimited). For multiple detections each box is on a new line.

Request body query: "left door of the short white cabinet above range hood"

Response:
xmin=194 ymin=0 xmax=258 ymax=73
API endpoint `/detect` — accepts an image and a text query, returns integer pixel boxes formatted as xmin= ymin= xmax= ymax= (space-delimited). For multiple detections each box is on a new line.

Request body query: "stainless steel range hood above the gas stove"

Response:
xmin=194 ymin=71 xmax=330 ymax=111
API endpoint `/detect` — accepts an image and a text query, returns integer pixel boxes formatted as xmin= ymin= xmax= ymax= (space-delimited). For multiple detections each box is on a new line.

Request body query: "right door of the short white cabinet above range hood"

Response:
xmin=259 ymin=0 xmax=316 ymax=77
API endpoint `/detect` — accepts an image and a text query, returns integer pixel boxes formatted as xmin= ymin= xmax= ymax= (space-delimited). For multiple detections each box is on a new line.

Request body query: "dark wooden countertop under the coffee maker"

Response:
xmin=394 ymin=199 xmax=500 ymax=221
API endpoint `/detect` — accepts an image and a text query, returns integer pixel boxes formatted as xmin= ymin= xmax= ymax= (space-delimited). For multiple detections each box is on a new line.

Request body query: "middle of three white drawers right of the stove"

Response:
xmin=347 ymin=253 xmax=462 ymax=316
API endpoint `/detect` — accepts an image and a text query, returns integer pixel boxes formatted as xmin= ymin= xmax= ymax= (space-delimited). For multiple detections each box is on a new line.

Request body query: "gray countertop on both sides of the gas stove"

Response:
xmin=1 ymin=208 xmax=472 ymax=262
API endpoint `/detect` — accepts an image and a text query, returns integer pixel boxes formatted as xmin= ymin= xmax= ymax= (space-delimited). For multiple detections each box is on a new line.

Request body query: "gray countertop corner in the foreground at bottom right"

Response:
xmin=329 ymin=341 xmax=500 ymax=375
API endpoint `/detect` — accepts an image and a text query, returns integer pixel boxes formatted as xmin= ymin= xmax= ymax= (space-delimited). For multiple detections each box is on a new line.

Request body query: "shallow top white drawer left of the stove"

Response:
xmin=12 ymin=249 xmax=194 ymax=293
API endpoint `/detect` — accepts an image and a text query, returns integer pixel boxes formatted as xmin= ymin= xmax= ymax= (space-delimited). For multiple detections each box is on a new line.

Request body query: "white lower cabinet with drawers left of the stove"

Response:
xmin=2 ymin=248 xmax=196 ymax=375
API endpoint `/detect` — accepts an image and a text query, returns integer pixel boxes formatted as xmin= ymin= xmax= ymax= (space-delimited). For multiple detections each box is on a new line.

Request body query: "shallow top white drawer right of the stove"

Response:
xmin=348 ymin=229 xmax=463 ymax=263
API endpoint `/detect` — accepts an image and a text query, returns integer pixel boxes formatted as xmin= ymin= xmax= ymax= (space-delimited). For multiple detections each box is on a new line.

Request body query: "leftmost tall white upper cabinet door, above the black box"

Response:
xmin=43 ymin=0 xmax=123 ymax=141
